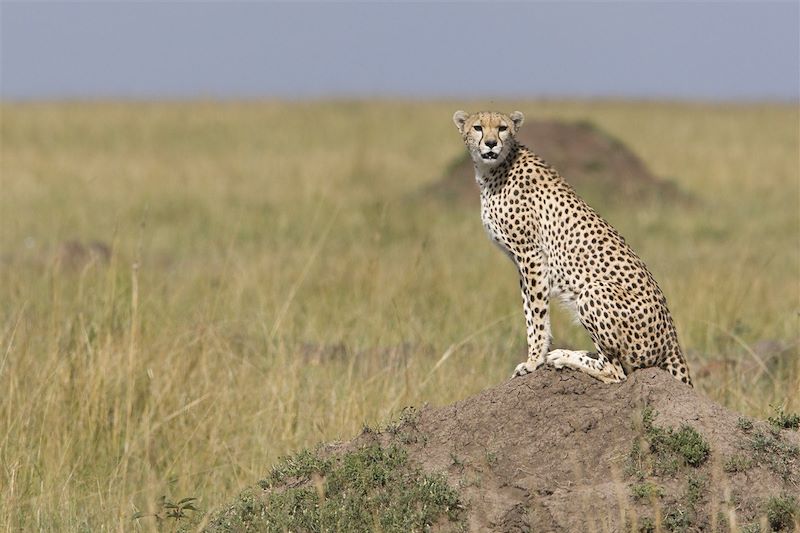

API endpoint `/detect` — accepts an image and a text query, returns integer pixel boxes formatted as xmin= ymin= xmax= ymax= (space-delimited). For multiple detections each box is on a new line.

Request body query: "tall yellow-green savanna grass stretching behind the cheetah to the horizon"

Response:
xmin=0 ymin=102 xmax=800 ymax=531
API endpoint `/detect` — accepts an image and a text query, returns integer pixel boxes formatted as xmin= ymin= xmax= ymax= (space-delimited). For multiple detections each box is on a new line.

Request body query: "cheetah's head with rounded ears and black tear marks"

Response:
xmin=453 ymin=111 xmax=525 ymax=167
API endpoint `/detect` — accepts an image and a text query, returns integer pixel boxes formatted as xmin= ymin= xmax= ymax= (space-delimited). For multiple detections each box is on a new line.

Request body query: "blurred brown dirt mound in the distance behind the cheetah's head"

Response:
xmin=434 ymin=120 xmax=689 ymax=205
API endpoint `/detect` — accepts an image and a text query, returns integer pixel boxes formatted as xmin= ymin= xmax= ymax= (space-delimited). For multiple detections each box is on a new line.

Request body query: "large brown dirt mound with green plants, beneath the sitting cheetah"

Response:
xmin=202 ymin=369 xmax=800 ymax=532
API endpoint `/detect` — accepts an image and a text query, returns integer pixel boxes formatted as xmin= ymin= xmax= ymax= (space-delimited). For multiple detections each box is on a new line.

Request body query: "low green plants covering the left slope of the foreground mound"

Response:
xmin=197 ymin=444 xmax=463 ymax=533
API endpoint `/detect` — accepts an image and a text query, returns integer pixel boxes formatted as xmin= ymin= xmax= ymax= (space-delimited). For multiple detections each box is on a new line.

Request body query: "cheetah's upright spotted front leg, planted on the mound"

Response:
xmin=511 ymin=252 xmax=552 ymax=378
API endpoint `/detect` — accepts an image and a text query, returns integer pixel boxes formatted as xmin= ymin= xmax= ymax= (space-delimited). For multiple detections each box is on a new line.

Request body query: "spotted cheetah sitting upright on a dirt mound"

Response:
xmin=453 ymin=111 xmax=692 ymax=385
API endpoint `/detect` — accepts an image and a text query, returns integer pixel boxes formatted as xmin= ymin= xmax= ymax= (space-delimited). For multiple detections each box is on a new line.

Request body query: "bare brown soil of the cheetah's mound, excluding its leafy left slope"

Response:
xmin=203 ymin=368 xmax=800 ymax=532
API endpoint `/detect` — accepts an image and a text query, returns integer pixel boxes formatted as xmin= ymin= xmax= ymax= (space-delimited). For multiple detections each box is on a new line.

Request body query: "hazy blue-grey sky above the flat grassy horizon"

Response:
xmin=0 ymin=0 xmax=800 ymax=101
